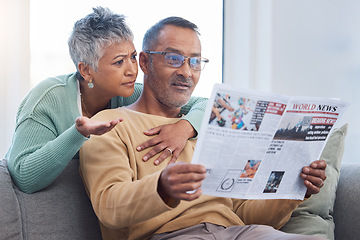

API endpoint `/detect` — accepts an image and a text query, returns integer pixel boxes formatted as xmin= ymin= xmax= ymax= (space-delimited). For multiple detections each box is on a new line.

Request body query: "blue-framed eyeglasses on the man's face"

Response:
xmin=144 ymin=51 xmax=209 ymax=71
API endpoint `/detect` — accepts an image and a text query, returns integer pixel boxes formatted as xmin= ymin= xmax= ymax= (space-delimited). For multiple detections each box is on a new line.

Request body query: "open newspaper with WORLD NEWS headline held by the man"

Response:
xmin=192 ymin=84 xmax=348 ymax=199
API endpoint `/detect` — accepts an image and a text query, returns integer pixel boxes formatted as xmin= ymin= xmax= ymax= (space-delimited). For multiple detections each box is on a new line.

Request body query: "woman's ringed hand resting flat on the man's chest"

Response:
xmin=136 ymin=120 xmax=196 ymax=165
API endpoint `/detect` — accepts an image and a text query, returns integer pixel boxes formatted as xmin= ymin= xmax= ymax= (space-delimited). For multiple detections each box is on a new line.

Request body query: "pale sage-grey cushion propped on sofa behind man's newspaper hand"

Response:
xmin=281 ymin=124 xmax=347 ymax=239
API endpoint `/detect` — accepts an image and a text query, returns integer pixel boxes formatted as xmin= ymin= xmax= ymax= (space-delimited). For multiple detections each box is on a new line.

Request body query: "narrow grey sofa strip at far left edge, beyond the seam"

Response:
xmin=0 ymin=159 xmax=23 ymax=240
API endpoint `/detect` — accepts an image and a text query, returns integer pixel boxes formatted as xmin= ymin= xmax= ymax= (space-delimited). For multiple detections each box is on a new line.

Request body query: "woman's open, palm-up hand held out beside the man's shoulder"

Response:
xmin=75 ymin=117 xmax=123 ymax=137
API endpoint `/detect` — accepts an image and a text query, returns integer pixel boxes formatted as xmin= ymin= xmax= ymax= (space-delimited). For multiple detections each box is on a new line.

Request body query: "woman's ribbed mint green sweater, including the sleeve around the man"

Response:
xmin=6 ymin=74 xmax=206 ymax=193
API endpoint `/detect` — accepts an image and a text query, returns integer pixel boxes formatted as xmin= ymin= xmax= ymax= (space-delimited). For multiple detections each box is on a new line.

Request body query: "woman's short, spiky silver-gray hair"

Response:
xmin=68 ymin=7 xmax=134 ymax=72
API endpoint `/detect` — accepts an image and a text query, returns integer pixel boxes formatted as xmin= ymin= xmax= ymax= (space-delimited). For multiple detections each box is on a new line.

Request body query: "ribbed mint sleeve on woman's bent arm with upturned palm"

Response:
xmin=8 ymin=118 xmax=86 ymax=193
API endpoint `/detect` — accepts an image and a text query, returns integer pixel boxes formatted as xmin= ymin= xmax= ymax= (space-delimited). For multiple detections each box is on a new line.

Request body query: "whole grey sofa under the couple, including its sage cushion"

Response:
xmin=0 ymin=126 xmax=360 ymax=240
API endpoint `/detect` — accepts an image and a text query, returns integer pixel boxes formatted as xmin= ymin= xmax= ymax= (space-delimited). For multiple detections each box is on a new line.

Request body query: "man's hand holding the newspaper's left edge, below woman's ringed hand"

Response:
xmin=158 ymin=162 xmax=206 ymax=202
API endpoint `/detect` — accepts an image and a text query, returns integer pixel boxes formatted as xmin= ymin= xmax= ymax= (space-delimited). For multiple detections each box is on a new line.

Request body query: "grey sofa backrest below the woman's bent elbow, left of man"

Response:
xmin=0 ymin=159 xmax=101 ymax=240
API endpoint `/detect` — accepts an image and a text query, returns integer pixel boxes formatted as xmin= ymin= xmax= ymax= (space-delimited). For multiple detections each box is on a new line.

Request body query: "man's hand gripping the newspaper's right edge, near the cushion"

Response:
xmin=300 ymin=160 xmax=326 ymax=198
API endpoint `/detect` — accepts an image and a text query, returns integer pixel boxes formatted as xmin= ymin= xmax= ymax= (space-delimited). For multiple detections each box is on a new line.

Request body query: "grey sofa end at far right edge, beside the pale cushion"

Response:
xmin=333 ymin=163 xmax=360 ymax=239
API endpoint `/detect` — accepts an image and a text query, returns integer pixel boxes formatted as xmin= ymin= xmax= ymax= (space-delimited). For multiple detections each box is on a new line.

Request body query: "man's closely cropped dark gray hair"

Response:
xmin=142 ymin=17 xmax=200 ymax=51
